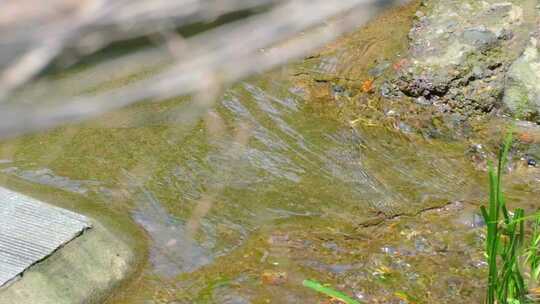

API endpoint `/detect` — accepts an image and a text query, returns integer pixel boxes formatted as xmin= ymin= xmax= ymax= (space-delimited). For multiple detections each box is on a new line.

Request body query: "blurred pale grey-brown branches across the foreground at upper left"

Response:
xmin=0 ymin=0 xmax=405 ymax=138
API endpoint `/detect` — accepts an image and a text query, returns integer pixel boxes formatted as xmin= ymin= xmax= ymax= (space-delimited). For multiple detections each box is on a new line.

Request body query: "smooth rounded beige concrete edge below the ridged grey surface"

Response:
xmin=0 ymin=221 xmax=136 ymax=304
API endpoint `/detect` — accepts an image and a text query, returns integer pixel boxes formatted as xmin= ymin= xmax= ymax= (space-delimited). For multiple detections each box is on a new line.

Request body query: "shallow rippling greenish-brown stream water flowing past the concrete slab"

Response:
xmin=0 ymin=2 xmax=536 ymax=303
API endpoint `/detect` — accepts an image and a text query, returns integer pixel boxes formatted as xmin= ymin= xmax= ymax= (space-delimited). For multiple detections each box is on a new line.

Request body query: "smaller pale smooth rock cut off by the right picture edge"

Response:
xmin=504 ymin=38 xmax=540 ymax=123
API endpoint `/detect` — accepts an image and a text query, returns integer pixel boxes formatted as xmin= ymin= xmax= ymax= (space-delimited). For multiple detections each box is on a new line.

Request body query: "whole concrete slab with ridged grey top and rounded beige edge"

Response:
xmin=0 ymin=187 xmax=134 ymax=304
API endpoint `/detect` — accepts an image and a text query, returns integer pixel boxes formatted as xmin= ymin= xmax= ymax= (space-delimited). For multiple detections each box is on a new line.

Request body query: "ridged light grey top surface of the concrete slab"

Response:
xmin=0 ymin=187 xmax=91 ymax=287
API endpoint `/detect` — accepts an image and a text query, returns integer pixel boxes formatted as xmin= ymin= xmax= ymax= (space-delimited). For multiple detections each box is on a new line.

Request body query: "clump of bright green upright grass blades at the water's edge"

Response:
xmin=480 ymin=134 xmax=540 ymax=304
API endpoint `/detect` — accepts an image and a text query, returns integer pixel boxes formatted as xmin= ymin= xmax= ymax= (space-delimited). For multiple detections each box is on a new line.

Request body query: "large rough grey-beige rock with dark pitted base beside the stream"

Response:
xmin=394 ymin=0 xmax=534 ymax=116
